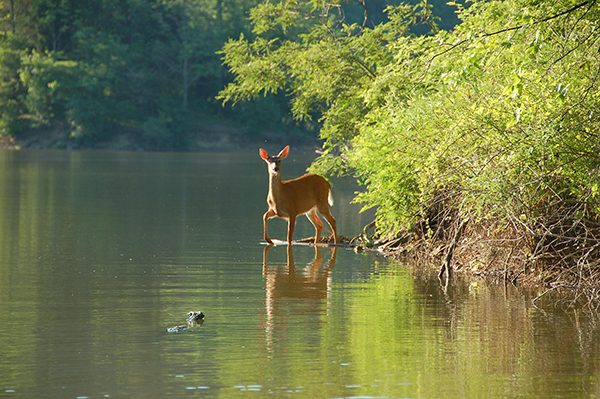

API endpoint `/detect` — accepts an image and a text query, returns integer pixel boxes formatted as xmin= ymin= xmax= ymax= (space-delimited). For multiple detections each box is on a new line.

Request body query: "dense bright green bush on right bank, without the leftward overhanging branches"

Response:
xmin=350 ymin=2 xmax=600 ymax=234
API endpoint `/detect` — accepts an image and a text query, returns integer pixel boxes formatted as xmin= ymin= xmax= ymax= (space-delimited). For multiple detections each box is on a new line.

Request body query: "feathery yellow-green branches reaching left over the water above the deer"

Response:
xmin=219 ymin=1 xmax=433 ymax=166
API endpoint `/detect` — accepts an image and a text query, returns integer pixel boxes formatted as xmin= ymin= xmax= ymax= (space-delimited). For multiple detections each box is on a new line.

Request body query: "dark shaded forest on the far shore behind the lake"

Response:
xmin=0 ymin=0 xmax=458 ymax=150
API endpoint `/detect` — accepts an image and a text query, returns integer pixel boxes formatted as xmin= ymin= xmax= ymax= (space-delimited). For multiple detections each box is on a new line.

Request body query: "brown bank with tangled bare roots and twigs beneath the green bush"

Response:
xmin=375 ymin=220 xmax=600 ymax=312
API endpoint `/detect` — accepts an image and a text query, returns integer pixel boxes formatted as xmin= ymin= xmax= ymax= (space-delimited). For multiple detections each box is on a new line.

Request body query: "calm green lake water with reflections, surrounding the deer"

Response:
xmin=0 ymin=148 xmax=600 ymax=399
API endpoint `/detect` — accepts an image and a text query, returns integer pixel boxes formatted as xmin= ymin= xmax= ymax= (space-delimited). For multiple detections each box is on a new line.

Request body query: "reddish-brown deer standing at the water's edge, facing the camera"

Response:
xmin=259 ymin=145 xmax=338 ymax=245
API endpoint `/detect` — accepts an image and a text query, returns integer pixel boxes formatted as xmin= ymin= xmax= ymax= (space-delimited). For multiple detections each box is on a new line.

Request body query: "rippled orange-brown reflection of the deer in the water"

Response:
xmin=263 ymin=245 xmax=337 ymax=349
